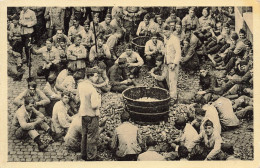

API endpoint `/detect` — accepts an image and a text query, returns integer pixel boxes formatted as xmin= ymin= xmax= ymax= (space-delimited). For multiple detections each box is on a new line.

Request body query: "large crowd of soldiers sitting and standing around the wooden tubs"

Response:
xmin=8 ymin=7 xmax=253 ymax=160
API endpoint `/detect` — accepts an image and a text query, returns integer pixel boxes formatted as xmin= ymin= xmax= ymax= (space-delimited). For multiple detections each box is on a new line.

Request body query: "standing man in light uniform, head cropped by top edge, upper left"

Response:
xmin=44 ymin=7 xmax=65 ymax=38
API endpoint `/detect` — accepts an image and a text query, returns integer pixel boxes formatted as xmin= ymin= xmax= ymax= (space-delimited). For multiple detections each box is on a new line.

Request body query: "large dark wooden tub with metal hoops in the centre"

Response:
xmin=122 ymin=87 xmax=170 ymax=122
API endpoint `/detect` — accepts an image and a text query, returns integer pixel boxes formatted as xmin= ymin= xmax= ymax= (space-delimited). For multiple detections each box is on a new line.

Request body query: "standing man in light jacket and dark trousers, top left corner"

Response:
xmin=19 ymin=7 xmax=37 ymax=62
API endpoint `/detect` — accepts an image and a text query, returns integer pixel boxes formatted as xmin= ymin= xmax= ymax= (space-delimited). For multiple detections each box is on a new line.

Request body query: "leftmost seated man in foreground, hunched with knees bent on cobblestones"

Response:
xmin=14 ymin=97 xmax=54 ymax=151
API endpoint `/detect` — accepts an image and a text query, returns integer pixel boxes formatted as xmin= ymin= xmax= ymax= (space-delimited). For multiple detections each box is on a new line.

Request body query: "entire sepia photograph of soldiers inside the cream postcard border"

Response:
xmin=1 ymin=2 xmax=259 ymax=166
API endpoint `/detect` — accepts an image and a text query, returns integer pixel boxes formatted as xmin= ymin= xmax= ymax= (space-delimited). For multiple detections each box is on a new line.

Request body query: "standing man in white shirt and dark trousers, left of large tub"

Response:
xmin=78 ymin=69 xmax=101 ymax=160
